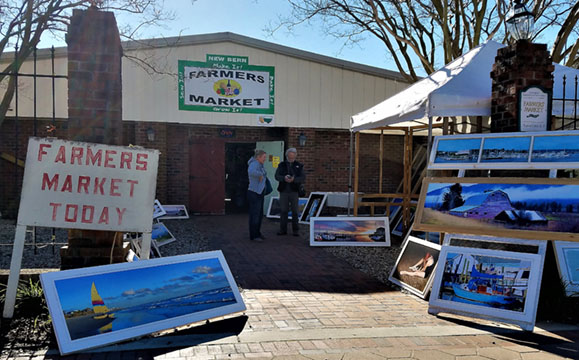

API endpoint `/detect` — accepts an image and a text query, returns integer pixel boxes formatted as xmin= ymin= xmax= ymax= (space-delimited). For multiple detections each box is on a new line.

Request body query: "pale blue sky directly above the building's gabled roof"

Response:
xmin=39 ymin=0 xmax=408 ymax=75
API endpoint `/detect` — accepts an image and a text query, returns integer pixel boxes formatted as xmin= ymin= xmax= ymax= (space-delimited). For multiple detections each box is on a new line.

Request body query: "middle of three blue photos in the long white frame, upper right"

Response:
xmin=480 ymin=136 xmax=531 ymax=163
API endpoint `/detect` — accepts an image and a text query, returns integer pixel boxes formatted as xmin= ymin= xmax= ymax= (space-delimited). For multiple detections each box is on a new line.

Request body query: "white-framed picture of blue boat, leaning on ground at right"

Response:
xmin=428 ymin=246 xmax=542 ymax=331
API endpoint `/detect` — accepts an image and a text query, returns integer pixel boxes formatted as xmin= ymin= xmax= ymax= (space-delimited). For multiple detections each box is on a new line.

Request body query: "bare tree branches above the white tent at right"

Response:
xmin=268 ymin=0 xmax=579 ymax=81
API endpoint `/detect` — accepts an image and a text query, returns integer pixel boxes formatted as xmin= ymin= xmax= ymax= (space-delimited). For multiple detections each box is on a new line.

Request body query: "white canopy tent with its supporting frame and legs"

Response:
xmin=350 ymin=40 xmax=579 ymax=228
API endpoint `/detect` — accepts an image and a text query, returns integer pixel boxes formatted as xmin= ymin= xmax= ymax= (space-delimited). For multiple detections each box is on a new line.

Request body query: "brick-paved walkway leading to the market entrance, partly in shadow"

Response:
xmin=5 ymin=215 xmax=579 ymax=360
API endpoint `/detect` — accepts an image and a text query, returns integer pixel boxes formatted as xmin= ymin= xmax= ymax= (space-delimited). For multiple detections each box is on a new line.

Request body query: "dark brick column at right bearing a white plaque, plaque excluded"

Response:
xmin=491 ymin=40 xmax=555 ymax=132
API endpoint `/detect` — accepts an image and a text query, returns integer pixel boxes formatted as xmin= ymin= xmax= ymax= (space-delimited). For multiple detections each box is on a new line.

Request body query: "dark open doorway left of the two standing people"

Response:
xmin=225 ymin=143 xmax=255 ymax=214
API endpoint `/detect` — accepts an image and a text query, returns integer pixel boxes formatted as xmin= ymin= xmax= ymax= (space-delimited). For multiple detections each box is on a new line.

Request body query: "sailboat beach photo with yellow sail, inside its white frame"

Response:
xmin=54 ymin=258 xmax=237 ymax=340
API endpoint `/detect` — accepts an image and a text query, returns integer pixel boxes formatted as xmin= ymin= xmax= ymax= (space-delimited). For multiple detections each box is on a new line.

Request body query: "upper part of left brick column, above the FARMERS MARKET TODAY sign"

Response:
xmin=66 ymin=7 xmax=123 ymax=145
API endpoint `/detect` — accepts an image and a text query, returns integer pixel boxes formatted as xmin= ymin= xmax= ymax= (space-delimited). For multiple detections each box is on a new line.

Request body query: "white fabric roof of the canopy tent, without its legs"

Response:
xmin=351 ymin=40 xmax=579 ymax=132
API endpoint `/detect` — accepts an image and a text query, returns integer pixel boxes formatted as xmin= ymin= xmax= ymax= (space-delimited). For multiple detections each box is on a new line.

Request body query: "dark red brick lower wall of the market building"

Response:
xmin=0 ymin=119 xmax=404 ymax=217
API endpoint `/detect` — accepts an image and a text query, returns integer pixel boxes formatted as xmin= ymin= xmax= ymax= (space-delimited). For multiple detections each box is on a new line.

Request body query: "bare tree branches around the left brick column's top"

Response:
xmin=0 ymin=0 xmax=174 ymax=127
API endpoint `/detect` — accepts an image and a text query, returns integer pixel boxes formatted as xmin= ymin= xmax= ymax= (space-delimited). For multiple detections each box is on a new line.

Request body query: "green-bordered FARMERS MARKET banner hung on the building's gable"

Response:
xmin=179 ymin=54 xmax=275 ymax=114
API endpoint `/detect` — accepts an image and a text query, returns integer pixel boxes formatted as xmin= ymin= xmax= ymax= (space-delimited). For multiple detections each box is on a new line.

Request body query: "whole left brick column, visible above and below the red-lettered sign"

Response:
xmin=60 ymin=7 xmax=128 ymax=269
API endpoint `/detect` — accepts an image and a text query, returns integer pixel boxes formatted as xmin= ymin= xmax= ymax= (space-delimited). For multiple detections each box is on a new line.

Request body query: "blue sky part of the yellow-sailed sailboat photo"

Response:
xmin=55 ymin=258 xmax=229 ymax=311
